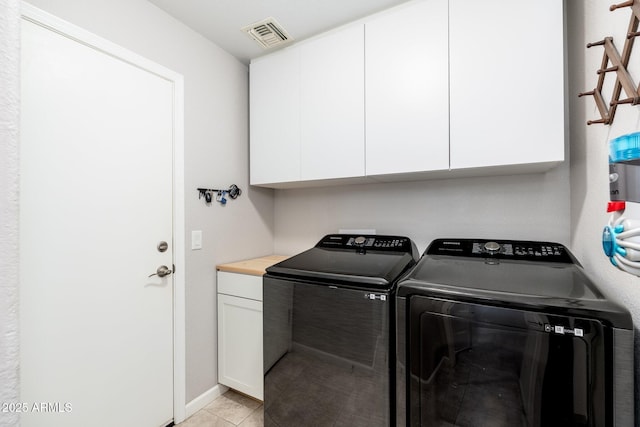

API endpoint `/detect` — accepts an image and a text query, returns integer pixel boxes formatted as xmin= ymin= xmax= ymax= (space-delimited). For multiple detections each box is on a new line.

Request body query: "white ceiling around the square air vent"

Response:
xmin=149 ymin=0 xmax=407 ymax=64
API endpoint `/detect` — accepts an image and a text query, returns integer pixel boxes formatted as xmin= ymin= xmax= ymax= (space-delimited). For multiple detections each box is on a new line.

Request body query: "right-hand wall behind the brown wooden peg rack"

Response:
xmin=566 ymin=0 xmax=640 ymax=414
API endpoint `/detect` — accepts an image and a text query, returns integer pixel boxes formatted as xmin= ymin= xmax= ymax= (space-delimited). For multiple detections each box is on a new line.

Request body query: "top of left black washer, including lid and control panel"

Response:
xmin=267 ymin=234 xmax=417 ymax=289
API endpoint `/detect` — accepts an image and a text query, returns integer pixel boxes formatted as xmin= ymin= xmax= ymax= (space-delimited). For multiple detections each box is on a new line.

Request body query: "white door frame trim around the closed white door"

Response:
xmin=21 ymin=1 xmax=186 ymax=424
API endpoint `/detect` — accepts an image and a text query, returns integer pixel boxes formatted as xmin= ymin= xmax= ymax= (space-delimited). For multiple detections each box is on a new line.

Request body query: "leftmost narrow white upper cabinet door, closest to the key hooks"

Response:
xmin=250 ymin=48 xmax=300 ymax=185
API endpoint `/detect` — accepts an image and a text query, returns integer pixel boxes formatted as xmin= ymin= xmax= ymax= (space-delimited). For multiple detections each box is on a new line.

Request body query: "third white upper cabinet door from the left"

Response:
xmin=365 ymin=0 xmax=449 ymax=175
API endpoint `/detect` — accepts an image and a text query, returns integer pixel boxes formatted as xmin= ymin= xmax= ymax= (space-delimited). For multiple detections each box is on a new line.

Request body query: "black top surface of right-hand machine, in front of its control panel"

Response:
xmin=398 ymin=239 xmax=632 ymax=328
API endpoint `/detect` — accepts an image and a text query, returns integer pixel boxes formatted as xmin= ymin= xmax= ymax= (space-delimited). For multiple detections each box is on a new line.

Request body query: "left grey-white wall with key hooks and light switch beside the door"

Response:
xmin=21 ymin=0 xmax=273 ymax=402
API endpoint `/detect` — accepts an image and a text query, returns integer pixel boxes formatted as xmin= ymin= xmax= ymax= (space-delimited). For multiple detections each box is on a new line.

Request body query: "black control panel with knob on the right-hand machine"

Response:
xmin=425 ymin=239 xmax=574 ymax=263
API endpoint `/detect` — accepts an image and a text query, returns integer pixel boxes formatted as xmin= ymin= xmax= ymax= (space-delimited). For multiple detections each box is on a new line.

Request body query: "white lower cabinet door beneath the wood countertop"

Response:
xmin=218 ymin=294 xmax=264 ymax=400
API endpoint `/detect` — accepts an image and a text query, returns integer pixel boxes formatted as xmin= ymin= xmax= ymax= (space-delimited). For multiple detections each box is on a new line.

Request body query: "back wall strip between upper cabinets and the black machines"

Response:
xmin=275 ymin=145 xmax=570 ymax=254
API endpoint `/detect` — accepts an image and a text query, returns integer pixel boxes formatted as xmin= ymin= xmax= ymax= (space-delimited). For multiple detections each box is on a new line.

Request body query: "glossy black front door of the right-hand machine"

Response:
xmin=407 ymin=296 xmax=611 ymax=427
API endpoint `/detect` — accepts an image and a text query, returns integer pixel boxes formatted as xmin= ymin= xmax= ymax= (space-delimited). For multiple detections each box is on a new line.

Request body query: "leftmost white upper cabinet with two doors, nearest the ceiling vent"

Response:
xmin=250 ymin=25 xmax=364 ymax=186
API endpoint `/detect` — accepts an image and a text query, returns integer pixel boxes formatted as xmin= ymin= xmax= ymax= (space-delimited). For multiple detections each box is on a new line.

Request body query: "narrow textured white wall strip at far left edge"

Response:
xmin=0 ymin=0 xmax=20 ymax=426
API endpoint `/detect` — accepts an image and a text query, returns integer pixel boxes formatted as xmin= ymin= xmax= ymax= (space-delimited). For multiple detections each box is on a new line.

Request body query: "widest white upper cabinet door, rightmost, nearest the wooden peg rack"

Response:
xmin=449 ymin=0 xmax=564 ymax=169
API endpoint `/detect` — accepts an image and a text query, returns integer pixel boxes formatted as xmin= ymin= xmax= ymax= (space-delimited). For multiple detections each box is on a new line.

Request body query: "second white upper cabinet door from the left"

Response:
xmin=300 ymin=25 xmax=364 ymax=181
